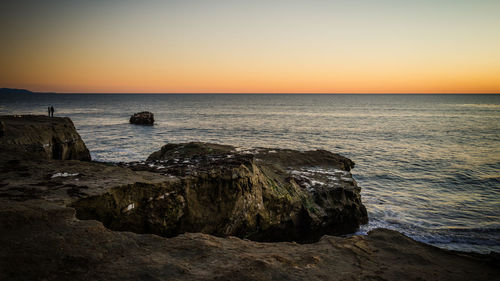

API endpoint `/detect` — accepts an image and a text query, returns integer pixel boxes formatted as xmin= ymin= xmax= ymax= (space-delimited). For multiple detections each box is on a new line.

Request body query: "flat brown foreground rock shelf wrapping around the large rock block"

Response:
xmin=0 ymin=115 xmax=499 ymax=280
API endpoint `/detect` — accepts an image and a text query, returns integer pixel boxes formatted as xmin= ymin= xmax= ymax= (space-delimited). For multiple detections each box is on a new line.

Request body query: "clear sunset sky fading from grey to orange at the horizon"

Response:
xmin=0 ymin=0 xmax=500 ymax=93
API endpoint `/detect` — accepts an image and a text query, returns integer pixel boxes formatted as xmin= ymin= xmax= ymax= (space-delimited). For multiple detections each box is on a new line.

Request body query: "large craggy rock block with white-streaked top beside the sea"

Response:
xmin=72 ymin=143 xmax=368 ymax=242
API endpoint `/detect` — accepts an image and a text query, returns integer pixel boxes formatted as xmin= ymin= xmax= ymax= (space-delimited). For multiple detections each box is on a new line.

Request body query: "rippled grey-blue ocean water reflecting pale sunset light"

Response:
xmin=0 ymin=94 xmax=500 ymax=253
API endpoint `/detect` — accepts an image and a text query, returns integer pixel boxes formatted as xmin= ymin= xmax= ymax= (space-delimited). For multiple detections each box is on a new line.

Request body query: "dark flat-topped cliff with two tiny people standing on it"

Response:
xmin=0 ymin=115 xmax=90 ymax=161
